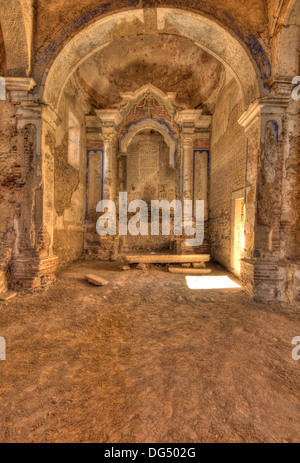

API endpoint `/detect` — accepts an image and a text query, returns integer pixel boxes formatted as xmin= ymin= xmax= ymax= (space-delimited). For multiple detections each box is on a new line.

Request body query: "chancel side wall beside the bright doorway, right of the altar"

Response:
xmin=209 ymin=80 xmax=246 ymax=269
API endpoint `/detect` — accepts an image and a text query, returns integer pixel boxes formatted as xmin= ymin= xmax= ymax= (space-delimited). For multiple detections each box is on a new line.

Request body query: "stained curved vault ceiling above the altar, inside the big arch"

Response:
xmin=77 ymin=35 xmax=224 ymax=109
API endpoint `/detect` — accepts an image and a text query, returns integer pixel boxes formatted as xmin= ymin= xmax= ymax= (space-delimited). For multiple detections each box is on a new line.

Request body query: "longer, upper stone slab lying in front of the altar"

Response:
xmin=125 ymin=254 xmax=210 ymax=264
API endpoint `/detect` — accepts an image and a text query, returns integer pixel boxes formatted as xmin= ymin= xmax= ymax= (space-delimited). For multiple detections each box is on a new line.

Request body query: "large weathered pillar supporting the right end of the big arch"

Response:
xmin=239 ymin=86 xmax=290 ymax=302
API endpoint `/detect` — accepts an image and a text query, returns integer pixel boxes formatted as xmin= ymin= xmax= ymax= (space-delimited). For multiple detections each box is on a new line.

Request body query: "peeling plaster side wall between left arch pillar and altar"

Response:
xmin=46 ymin=79 xmax=88 ymax=266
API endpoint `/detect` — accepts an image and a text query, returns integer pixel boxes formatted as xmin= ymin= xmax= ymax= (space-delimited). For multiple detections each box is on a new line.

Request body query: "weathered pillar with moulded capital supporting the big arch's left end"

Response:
xmin=6 ymin=78 xmax=58 ymax=289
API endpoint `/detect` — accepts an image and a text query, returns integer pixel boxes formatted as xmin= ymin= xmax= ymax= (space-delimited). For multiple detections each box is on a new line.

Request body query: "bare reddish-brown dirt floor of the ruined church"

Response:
xmin=0 ymin=261 xmax=300 ymax=443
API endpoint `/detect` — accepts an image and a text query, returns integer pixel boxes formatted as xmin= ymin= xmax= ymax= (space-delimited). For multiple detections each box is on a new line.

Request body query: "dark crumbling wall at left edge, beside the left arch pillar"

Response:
xmin=0 ymin=99 xmax=34 ymax=293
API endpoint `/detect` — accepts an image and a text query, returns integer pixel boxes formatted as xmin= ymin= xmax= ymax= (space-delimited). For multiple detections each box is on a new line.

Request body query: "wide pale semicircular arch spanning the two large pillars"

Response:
xmin=35 ymin=8 xmax=269 ymax=109
